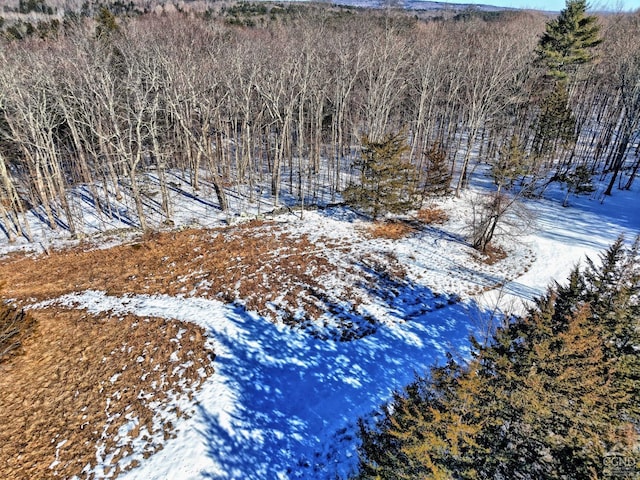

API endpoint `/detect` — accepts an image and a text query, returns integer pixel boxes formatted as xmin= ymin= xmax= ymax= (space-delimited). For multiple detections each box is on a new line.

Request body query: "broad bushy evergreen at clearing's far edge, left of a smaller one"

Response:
xmin=343 ymin=133 xmax=417 ymax=220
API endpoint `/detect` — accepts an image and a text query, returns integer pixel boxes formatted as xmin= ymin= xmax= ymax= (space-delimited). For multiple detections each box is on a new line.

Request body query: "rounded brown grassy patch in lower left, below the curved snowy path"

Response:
xmin=0 ymin=308 xmax=213 ymax=480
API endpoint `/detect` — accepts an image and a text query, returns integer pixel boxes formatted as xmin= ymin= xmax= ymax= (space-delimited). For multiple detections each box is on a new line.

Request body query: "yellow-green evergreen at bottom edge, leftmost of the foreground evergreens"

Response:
xmin=357 ymin=356 xmax=495 ymax=480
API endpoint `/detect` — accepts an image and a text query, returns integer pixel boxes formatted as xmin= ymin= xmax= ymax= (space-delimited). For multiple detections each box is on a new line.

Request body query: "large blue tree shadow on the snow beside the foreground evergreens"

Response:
xmin=192 ymin=272 xmax=488 ymax=480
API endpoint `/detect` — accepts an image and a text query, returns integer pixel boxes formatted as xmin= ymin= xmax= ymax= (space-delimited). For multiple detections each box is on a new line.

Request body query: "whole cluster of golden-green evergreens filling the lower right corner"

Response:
xmin=357 ymin=239 xmax=640 ymax=479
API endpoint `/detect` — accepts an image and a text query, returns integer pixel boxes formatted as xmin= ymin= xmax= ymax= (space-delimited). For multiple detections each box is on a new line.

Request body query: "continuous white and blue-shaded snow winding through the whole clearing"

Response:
xmin=2 ymin=174 xmax=640 ymax=480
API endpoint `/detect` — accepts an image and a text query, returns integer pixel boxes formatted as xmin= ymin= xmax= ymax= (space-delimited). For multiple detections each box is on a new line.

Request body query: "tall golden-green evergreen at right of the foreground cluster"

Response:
xmin=480 ymin=295 xmax=629 ymax=478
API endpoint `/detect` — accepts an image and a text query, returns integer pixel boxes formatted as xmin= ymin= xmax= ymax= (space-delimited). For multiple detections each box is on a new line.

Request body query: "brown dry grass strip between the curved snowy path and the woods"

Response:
xmin=0 ymin=222 xmax=338 ymax=317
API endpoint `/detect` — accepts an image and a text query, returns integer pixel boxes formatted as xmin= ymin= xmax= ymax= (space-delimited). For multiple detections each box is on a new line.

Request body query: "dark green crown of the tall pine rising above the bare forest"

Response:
xmin=537 ymin=0 xmax=602 ymax=79
